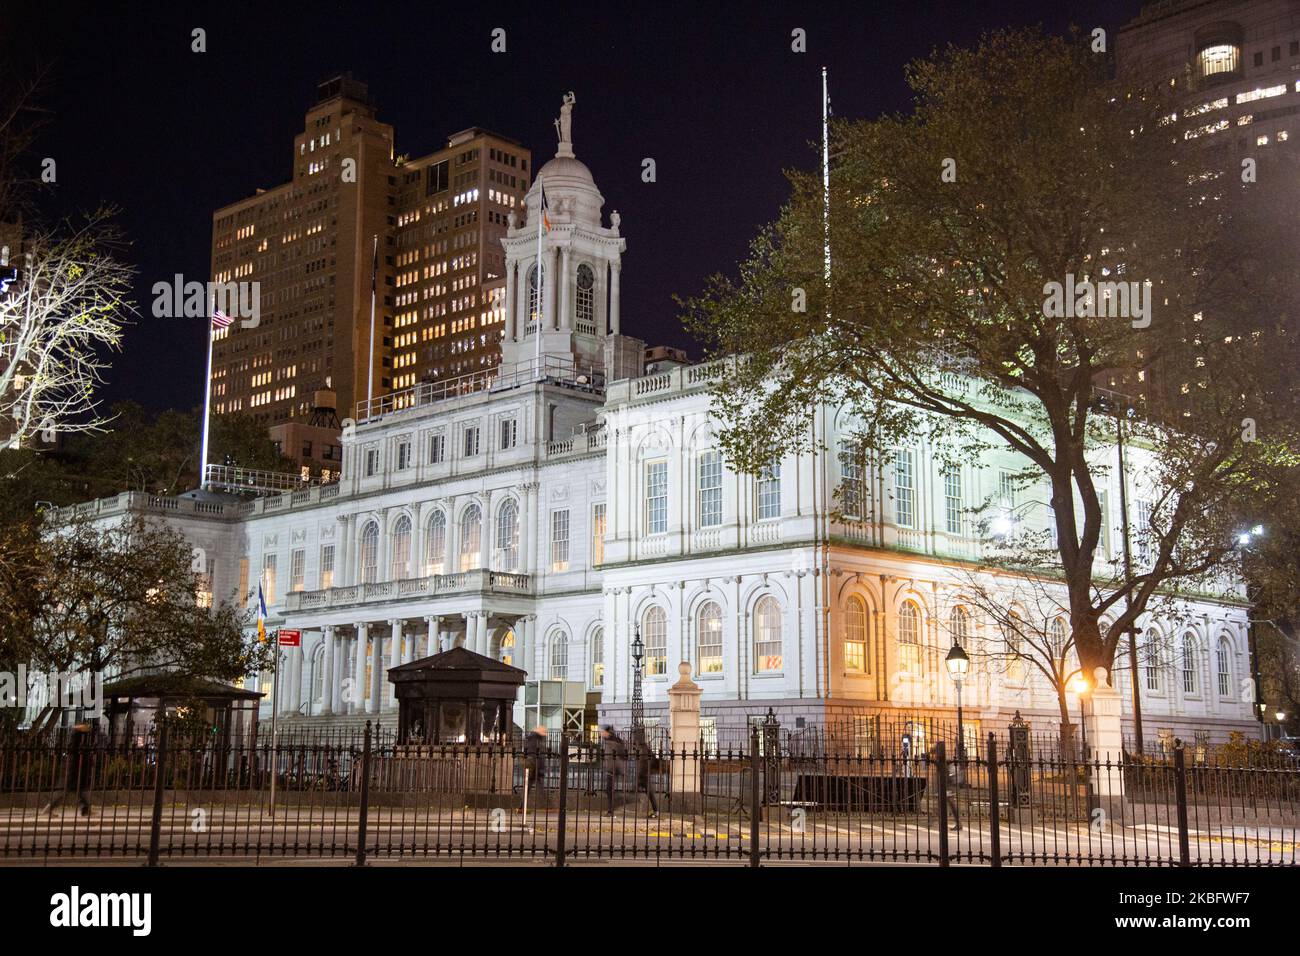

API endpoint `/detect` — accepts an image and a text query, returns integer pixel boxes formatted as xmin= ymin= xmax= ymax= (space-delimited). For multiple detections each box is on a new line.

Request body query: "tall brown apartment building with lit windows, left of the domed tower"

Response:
xmin=212 ymin=75 xmax=532 ymax=471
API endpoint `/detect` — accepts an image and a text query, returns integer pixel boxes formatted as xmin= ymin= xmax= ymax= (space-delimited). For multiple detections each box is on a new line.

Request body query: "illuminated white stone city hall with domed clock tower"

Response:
xmin=63 ymin=103 xmax=1257 ymax=747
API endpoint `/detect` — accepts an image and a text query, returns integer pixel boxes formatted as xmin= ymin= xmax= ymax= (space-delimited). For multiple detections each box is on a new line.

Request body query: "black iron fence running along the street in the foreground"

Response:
xmin=0 ymin=727 xmax=1300 ymax=866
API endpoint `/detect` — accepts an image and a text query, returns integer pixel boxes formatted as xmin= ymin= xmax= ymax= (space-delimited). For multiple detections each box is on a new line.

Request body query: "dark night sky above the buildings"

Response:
xmin=0 ymin=0 xmax=1141 ymax=410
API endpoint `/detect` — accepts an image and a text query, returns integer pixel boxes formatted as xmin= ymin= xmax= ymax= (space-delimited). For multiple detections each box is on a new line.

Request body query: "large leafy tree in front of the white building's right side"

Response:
xmin=685 ymin=30 xmax=1296 ymax=672
